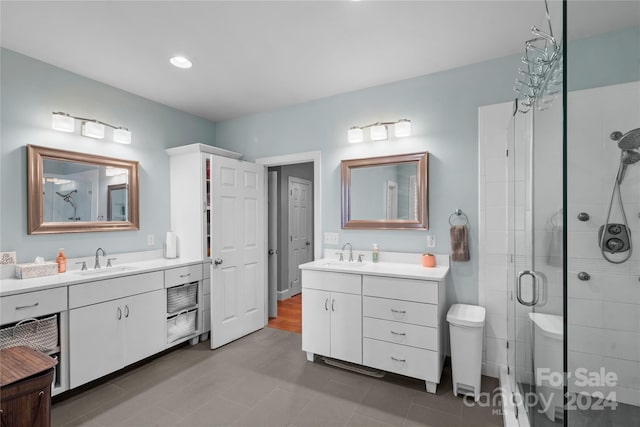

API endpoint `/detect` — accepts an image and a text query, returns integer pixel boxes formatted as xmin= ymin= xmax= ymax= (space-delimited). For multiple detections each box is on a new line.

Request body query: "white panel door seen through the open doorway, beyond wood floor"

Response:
xmin=288 ymin=177 xmax=313 ymax=296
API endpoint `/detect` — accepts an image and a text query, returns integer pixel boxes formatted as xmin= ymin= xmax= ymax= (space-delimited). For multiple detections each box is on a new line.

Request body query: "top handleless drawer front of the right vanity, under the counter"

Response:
xmin=362 ymin=276 xmax=438 ymax=304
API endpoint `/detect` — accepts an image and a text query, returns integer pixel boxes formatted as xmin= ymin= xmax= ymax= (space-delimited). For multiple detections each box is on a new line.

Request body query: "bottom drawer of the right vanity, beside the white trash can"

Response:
xmin=362 ymin=338 xmax=441 ymax=383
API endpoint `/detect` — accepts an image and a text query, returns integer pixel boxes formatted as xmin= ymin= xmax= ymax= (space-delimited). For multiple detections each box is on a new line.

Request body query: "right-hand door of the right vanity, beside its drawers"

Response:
xmin=332 ymin=292 xmax=362 ymax=364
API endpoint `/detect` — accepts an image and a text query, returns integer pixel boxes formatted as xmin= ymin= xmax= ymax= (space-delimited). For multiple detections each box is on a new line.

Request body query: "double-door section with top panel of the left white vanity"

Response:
xmin=69 ymin=271 xmax=166 ymax=388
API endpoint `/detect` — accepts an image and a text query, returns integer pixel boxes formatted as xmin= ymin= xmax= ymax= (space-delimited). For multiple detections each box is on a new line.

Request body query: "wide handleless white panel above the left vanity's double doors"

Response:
xmin=69 ymin=271 xmax=164 ymax=308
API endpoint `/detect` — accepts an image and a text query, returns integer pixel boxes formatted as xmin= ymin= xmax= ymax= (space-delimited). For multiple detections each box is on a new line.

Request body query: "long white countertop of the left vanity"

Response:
xmin=0 ymin=258 xmax=206 ymax=297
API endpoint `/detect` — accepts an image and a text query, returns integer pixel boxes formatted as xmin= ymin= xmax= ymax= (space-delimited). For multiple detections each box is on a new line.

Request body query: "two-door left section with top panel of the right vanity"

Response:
xmin=302 ymin=270 xmax=362 ymax=364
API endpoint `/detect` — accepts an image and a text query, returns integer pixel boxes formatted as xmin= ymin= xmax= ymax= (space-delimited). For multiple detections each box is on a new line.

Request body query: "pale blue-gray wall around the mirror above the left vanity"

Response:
xmin=0 ymin=49 xmax=220 ymax=262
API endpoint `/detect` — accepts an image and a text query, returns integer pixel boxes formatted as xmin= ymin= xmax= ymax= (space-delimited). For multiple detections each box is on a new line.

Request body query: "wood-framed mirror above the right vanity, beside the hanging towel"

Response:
xmin=340 ymin=152 xmax=429 ymax=230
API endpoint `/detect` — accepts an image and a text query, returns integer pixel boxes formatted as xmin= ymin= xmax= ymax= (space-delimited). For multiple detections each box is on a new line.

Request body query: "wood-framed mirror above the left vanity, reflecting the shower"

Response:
xmin=27 ymin=145 xmax=140 ymax=234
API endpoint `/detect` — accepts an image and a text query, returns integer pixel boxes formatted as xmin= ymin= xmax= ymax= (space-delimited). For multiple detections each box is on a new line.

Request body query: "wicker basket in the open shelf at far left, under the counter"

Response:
xmin=0 ymin=314 xmax=58 ymax=353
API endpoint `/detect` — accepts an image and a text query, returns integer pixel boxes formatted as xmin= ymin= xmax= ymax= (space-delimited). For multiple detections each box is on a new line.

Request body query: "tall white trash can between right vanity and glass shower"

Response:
xmin=447 ymin=304 xmax=485 ymax=402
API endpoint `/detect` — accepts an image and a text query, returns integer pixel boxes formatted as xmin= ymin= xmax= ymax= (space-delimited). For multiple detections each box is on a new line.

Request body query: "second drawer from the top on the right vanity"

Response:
xmin=362 ymin=297 xmax=438 ymax=327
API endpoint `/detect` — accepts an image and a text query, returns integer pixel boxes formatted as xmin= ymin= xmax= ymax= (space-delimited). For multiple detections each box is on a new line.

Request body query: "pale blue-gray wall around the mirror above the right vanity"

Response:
xmin=216 ymin=28 xmax=640 ymax=304
